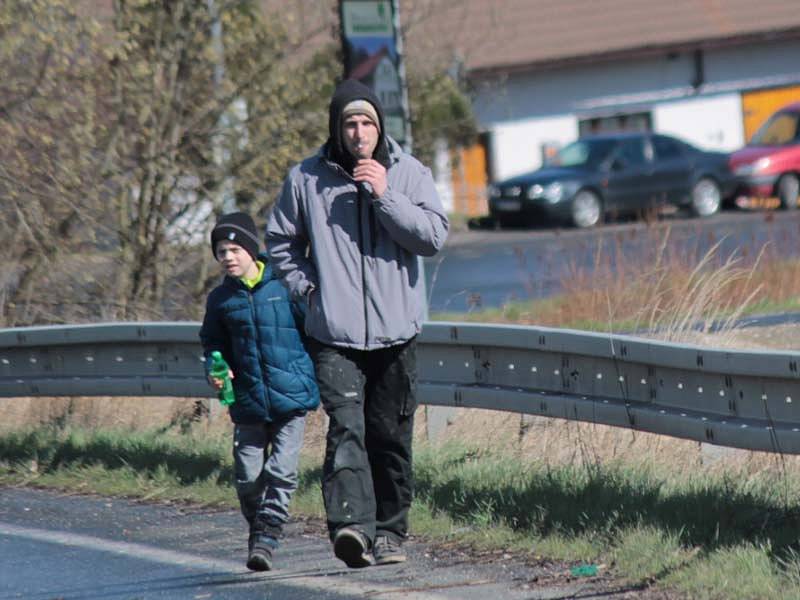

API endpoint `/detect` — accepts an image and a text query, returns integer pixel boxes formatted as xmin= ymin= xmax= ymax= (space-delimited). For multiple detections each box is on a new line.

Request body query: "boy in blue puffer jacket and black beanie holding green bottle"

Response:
xmin=200 ymin=212 xmax=319 ymax=571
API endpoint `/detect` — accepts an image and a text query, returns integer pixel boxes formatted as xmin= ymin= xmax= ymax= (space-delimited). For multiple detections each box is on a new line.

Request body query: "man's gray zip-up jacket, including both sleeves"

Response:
xmin=266 ymin=138 xmax=448 ymax=350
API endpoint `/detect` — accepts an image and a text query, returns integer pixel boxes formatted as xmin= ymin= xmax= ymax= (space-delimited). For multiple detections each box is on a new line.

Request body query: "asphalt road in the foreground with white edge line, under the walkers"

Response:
xmin=0 ymin=488 xmax=628 ymax=600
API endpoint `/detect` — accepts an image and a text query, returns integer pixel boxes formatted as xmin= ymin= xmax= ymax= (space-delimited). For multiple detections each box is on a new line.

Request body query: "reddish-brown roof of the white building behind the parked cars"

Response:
xmin=409 ymin=0 xmax=800 ymax=76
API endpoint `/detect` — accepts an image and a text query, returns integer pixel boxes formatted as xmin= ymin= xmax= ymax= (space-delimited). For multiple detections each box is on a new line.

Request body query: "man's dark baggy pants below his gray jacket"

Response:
xmin=310 ymin=339 xmax=417 ymax=541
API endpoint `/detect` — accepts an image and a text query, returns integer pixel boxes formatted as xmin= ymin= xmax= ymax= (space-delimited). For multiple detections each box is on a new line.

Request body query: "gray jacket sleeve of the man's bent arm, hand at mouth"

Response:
xmin=375 ymin=164 xmax=449 ymax=256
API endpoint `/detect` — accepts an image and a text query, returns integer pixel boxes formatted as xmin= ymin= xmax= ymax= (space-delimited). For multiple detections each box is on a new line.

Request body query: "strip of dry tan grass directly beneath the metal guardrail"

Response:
xmin=6 ymin=397 xmax=800 ymax=488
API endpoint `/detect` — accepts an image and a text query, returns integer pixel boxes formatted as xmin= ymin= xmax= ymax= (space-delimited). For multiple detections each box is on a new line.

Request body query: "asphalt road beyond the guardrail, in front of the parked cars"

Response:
xmin=425 ymin=211 xmax=800 ymax=312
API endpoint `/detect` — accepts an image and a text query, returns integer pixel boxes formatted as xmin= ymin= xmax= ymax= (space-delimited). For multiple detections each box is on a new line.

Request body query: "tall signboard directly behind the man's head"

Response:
xmin=340 ymin=0 xmax=408 ymax=145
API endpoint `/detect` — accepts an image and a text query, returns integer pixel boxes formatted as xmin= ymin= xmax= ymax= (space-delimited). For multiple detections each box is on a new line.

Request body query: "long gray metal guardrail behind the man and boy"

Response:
xmin=0 ymin=322 xmax=800 ymax=454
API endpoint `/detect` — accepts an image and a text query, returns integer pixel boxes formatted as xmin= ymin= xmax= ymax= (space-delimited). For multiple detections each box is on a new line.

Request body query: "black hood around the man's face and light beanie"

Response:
xmin=326 ymin=79 xmax=389 ymax=173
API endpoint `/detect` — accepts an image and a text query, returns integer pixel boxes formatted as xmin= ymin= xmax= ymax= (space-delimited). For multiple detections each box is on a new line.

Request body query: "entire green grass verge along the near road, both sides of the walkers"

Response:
xmin=0 ymin=427 xmax=800 ymax=598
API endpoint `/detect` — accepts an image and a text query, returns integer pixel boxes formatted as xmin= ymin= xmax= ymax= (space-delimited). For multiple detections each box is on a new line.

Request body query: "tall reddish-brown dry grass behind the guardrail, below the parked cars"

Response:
xmin=469 ymin=226 xmax=800 ymax=343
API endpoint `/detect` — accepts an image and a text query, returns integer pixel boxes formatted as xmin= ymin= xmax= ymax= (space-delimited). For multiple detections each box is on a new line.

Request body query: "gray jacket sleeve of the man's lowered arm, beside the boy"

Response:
xmin=265 ymin=173 xmax=317 ymax=298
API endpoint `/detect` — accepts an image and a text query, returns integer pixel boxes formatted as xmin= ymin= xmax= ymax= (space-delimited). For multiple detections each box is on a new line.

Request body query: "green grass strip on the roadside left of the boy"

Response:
xmin=0 ymin=426 xmax=236 ymax=506
